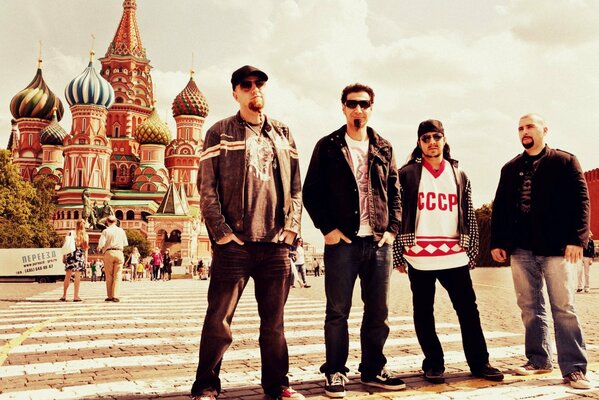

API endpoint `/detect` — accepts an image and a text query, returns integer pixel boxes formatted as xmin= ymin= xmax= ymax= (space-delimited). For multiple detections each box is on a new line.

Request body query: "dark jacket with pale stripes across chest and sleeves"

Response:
xmin=198 ymin=113 xmax=302 ymax=241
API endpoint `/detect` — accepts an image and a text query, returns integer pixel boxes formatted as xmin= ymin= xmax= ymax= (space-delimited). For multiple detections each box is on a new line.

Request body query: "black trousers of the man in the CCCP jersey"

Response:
xmin=408 ymin=266 xmax=489 ymax=371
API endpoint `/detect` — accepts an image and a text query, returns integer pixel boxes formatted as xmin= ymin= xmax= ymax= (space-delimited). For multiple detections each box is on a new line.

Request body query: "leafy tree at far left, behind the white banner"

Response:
xmin=0 ymin=150 xmax=62 ymax=248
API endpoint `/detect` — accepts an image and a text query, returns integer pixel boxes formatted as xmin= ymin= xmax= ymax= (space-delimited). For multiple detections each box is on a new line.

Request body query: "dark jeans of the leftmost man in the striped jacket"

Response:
xmin=191 ymin=242 xmax=291 ymax=397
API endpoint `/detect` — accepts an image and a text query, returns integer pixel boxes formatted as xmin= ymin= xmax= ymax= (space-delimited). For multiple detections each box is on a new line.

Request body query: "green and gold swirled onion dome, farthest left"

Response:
xmin=10 ymin=67 xmax=64 ymax=121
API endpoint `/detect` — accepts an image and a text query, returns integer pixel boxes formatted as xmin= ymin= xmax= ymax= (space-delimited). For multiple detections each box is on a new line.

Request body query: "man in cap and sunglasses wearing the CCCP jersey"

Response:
xmin=393 ymin=119 xmax=503 ymax=383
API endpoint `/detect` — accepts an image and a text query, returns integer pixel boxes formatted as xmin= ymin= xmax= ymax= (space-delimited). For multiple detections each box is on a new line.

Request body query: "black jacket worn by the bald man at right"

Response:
xmin=491 ymin=146 xmax=590 ymax=256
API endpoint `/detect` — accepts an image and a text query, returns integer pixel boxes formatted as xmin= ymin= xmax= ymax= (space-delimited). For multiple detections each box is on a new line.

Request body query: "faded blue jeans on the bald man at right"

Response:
xmin=511 ymin=249 xmax=587 ymax=376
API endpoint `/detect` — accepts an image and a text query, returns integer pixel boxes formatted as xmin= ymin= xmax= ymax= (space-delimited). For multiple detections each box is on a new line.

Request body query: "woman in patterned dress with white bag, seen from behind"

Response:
xmin=60 ymin=219 xmax=89 ymax=301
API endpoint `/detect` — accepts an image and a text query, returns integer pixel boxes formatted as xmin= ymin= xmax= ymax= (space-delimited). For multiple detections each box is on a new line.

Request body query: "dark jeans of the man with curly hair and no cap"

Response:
xmin=320 ymin=237 xmax=392 ymax=376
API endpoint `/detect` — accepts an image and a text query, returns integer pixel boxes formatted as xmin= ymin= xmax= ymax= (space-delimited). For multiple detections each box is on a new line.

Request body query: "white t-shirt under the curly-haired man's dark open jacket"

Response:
xmin=345 ymin=133 xmax=374 ymax=236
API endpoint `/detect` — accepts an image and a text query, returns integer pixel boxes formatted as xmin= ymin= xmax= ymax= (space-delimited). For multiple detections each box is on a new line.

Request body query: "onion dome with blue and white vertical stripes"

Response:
xmin=64 ymin=61 xmax=114 ymax=108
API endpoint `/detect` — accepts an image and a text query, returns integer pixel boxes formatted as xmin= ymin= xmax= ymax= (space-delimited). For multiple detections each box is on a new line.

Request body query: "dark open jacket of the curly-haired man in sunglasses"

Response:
xmin=303 ymin=125 xmax=401 ymax=240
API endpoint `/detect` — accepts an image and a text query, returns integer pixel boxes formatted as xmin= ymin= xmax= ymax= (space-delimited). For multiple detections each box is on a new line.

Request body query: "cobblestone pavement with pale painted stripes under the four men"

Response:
xmin=0 ymin=268 xmax=599 ymax=400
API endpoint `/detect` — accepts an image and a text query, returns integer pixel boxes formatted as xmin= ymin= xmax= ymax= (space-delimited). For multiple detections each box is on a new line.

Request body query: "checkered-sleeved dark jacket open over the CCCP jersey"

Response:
xmin=393 ymin=158 xmax=479 ymax=268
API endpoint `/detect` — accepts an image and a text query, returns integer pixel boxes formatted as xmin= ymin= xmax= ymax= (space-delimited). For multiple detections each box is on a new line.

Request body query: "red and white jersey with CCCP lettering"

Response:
xmin=404 ymin=159 xmax=469 ymax=271
